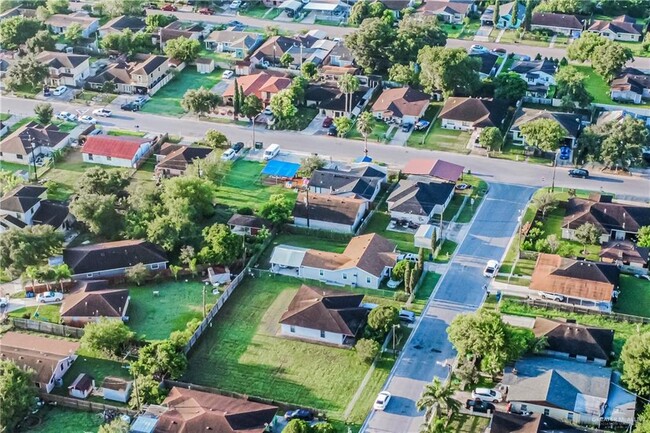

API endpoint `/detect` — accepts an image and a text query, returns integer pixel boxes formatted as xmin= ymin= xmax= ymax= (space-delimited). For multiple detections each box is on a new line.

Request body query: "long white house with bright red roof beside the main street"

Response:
xmin=81 ymin=135 xmax=153 ymax=168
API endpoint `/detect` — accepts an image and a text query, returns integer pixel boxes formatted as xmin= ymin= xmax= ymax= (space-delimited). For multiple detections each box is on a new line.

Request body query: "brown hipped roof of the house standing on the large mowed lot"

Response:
xmin=280 ymin=284 xmax=368 ymax=337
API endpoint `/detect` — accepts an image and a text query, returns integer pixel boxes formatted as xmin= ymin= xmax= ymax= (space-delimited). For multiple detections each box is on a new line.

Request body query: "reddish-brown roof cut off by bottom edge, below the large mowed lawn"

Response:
xmin=154 ymin=387 xmax=278 ymax=433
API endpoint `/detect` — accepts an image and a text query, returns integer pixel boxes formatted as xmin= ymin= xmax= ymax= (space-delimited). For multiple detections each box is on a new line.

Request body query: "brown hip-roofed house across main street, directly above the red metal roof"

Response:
xmin=438 ymin=97 xmax=508 ymax=131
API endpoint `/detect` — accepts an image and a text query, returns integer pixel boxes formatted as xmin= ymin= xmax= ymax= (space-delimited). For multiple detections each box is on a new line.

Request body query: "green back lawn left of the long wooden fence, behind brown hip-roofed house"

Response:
xmin=128 ymin=280 xmax=218 ymax=340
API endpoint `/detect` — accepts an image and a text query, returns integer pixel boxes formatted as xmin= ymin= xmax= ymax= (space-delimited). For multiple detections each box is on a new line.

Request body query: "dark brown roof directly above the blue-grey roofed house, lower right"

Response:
xmin=533 ymin=317 xmax=614 ymax=359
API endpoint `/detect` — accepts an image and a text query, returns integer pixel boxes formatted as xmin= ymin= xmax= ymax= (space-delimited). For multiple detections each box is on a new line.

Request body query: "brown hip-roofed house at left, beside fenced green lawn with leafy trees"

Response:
xmin=60 ymin=280 xmax=131 ymax=327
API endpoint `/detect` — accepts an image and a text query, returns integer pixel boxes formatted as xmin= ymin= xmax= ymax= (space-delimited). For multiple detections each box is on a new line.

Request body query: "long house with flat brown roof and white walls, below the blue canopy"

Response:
xmin=292 ymin=192 xmax=368 ymax=233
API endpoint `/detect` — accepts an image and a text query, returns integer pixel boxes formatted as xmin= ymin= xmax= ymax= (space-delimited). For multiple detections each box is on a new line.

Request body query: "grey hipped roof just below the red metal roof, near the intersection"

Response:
xmin=386 ymin=179 xmax=454 ymax=216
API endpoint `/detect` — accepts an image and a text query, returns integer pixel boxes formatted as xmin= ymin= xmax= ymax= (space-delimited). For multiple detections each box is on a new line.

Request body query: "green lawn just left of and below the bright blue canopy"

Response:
xmin=216 ymin=161 xmax=296 ymax=209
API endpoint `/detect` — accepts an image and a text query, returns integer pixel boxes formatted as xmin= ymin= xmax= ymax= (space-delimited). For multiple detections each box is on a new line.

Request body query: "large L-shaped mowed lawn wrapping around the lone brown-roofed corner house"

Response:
xmin=182 ymin=276 xmax=380 ymax=419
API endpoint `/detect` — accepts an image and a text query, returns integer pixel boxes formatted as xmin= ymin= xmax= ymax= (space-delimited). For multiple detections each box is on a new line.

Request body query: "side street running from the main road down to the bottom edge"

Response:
xmin=362 ymin=183 xmax=535 ymax=433
